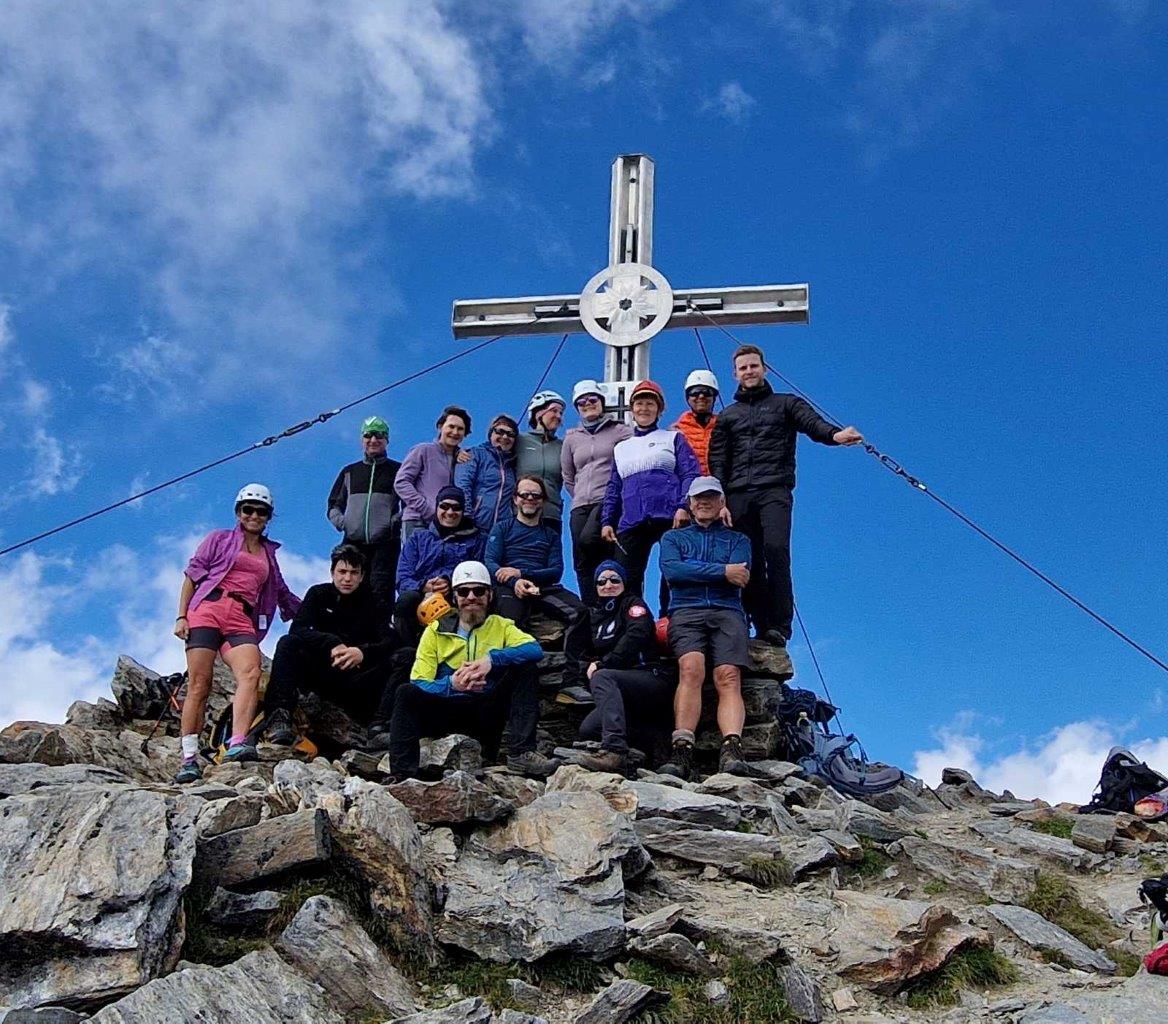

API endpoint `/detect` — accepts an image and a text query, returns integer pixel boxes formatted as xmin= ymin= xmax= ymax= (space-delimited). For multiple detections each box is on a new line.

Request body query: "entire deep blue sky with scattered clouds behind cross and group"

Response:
xmin=0 ymin=0 xmax=1168 ymax=800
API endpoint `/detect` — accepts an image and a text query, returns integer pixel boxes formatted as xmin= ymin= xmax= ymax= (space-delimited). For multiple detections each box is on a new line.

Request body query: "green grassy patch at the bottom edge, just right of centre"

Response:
xmin=627 ymin=956 xmax=798 ymax=1024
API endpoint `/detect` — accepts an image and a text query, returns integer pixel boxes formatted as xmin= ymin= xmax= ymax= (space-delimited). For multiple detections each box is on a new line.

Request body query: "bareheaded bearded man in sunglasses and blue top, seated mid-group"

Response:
xmin=485 ymin=476 xmax=584 ymax=626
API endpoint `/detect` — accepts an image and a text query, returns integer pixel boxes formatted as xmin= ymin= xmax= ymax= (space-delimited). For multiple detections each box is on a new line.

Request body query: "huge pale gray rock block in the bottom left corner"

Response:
xmin=0 ymin=786 xmax=202 ymax=1009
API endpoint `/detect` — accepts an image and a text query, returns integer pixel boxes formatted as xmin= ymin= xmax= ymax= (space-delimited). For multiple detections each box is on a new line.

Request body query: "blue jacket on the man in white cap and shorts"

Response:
xmin=659 ymin=520 xmax=750 ymax=618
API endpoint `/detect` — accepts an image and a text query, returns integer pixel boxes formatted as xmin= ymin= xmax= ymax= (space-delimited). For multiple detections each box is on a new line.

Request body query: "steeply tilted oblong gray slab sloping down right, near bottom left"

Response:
xmin=273 ymin=896 xmax=417 ymax=1019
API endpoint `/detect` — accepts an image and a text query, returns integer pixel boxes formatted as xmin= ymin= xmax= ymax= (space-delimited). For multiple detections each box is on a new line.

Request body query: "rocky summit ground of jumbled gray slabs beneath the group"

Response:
xmin=0 ymin=648 xmax=1168 ymax=1024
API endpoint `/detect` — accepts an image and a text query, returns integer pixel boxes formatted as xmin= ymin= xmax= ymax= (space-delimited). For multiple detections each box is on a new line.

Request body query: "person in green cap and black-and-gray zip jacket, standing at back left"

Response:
xmin=328 ymin=416 xmax=402 ymax=607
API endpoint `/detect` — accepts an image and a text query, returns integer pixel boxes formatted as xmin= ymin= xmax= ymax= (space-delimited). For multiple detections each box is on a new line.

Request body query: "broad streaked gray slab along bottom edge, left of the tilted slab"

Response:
xmin=90 ymin=949 xmax=347 ymax=1024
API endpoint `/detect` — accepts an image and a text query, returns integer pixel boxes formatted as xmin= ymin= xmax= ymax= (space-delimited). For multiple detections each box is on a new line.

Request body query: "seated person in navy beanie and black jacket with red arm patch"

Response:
xmin=564 ymin=559 xmax=677 ymax=772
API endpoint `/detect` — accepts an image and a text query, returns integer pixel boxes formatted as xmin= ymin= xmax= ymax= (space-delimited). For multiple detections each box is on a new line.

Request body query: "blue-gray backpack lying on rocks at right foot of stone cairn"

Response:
xmin=774 ymin=683 xmax=904 ymax=797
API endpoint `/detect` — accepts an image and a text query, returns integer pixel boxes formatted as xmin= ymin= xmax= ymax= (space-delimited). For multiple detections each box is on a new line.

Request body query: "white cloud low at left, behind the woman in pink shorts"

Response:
xmin=0 ymin=534 xmax=328 ymax=726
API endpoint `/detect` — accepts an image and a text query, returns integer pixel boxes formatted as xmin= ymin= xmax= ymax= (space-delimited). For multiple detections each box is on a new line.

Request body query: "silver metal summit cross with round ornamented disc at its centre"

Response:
xmin=451 ymin=153 xmax=809 ymax=415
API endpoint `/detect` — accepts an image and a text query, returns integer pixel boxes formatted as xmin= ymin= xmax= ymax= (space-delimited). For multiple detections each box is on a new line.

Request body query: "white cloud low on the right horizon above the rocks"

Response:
xmin=913 ymin=722 xmax=1168 ymax=803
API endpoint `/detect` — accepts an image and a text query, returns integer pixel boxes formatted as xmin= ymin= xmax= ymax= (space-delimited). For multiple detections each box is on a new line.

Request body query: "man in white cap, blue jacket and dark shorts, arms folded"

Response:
xmin=660 ymin=476 xmax=750 ymax=779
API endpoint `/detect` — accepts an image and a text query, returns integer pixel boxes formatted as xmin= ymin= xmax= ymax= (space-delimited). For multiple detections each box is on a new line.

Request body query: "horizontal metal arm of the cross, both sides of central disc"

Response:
xmin=451 ymin=285 xmax=811 ymax=339
